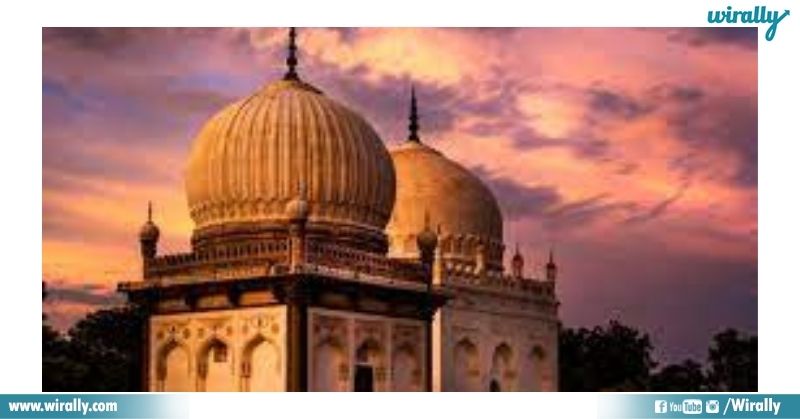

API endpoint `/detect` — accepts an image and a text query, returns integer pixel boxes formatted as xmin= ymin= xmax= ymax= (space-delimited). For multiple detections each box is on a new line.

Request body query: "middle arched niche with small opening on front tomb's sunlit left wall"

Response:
xmin=197 ymin=337 xmax=237 ymax=391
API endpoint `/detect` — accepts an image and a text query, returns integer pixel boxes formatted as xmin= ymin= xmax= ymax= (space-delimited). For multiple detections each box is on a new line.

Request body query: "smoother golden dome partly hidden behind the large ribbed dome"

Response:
xmin=386 ymin=141 xmax=503 ymax=269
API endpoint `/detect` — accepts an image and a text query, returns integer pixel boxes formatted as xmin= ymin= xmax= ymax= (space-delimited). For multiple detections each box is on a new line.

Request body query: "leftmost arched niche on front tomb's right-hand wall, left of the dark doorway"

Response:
xmin=311 ymin=338 xmax=349 ymax=391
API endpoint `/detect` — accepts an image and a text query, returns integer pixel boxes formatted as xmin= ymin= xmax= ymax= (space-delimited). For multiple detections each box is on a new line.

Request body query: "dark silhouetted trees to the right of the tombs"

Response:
xmin=559 ymin=321 xmax=758 ymax=392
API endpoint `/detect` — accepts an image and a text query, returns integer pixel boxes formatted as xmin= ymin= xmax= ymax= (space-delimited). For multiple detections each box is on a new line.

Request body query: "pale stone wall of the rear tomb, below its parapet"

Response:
xmin=433 ymin=289 xmax=558 ymax=391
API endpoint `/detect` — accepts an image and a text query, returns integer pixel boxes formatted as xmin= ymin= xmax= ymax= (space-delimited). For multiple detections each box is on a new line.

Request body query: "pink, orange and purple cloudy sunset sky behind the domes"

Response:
xmin=42 ymin=28 xmax=758 ymax=362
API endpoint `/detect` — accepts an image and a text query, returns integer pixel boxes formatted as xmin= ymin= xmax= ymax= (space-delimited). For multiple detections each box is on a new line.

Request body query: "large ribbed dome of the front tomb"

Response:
xmin=186 ymin=79 xmax=395 ymax=240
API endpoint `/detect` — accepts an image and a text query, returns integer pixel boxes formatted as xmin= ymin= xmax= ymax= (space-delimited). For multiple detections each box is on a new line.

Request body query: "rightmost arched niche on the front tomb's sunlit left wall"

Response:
xmin=242 ymin=335 xmax=283 ymax=391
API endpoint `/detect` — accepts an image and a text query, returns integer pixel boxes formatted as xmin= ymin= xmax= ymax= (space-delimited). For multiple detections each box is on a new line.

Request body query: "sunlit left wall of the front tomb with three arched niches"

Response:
xmin=149 ymin=306 xmax=286 ymax=391
